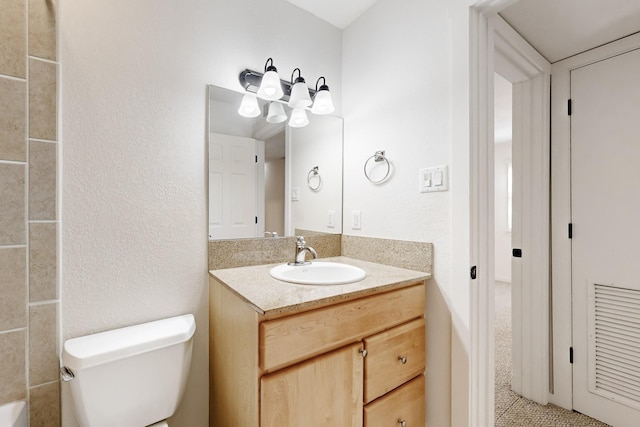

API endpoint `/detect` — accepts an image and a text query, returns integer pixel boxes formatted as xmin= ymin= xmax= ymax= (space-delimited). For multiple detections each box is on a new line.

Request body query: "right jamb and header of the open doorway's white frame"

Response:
xmin=490 ymin=16 xmax=552 ymax=404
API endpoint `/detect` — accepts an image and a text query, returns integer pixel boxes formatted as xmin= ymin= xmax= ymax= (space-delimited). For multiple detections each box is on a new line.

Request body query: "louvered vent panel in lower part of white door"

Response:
xmin=590 ymin=284 xmax=640 ymax=408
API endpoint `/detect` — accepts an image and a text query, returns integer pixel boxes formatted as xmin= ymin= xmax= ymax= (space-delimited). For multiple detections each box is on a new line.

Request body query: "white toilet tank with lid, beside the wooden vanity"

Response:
xmin=61 ymin=314 xmax=196 ymax=427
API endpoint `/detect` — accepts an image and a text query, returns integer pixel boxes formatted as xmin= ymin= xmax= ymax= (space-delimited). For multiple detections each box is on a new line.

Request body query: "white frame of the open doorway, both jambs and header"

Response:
xmin=470 ymin=9 xmax=551 ymax=426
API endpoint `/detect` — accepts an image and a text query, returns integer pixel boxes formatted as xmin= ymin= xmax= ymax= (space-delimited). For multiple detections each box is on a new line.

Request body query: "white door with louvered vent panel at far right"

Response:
xmin=571 ymin=50 xmax=640 ymax=427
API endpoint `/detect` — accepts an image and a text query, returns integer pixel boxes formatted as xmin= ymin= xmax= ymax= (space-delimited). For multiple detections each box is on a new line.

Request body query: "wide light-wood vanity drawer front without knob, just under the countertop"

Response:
xmin=259 ymin=283 xmax=424 ymax=371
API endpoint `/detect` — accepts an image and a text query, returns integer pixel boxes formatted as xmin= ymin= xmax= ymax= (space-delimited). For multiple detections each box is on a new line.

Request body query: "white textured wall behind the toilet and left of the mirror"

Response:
xmin=59 ymin=0 xmax=341 ymax=427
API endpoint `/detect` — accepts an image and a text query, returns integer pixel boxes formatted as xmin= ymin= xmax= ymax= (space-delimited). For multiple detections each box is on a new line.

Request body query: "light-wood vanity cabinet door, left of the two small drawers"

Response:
xmin=260 ymin=343 xmax=364 ymax=427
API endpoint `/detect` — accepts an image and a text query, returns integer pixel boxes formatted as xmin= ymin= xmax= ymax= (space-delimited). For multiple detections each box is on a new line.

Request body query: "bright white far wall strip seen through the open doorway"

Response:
xmin=493 ymin=141 xmax=512 ymax=283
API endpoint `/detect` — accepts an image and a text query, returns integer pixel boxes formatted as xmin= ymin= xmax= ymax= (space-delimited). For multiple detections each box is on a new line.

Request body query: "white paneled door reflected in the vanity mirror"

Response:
xmin=209 ymin=133 xmax=258 ymax=239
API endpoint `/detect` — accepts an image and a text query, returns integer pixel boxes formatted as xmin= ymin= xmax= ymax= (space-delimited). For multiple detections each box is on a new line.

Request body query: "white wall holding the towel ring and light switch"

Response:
xmin=342 ymin=0 xmax=472 ymax=426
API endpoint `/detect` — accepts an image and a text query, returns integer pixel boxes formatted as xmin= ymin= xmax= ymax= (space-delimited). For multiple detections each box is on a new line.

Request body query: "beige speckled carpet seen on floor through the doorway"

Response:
xmin=495 ymin=282 xmax=607 ymax=427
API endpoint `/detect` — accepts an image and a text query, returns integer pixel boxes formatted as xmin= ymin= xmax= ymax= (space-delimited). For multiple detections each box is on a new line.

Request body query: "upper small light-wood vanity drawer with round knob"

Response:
xmin=364 ymin=318 xmax=425 ymax=403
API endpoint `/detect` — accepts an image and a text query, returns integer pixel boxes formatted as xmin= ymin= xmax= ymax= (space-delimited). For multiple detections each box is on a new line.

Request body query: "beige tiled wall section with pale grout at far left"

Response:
xmin=0 ymin=0 xmax=60 ymax=427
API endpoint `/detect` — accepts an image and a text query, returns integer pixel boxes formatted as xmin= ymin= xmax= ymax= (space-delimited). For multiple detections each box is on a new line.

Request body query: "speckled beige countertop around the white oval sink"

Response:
xmin=209 ymin=256 xmax=431 ymax=317
